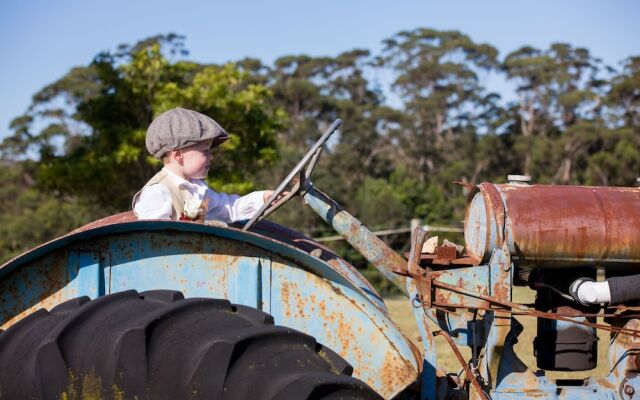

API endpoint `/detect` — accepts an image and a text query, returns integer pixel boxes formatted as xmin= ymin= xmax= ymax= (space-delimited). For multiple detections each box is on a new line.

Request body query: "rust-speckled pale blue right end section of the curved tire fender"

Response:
xmin=271 ymin=260 xmax=420 ymax=398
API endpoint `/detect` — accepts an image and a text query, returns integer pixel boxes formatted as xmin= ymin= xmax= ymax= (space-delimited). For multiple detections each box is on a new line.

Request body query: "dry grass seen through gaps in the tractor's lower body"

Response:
xmin=384 ymin=287 xmax=609 ymax=379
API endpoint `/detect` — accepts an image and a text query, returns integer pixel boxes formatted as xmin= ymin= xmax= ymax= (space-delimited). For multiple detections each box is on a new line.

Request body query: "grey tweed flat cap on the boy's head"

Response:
xmin=146 ymin=107 xmax=229 ymax=159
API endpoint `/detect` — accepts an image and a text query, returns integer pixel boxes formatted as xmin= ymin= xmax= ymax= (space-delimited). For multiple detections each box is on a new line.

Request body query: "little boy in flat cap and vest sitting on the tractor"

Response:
xmin=132 ymin=107 xmax=273 ymax=222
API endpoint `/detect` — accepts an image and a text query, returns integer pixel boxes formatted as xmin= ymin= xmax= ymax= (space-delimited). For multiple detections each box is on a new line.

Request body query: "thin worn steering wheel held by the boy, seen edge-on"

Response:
xmin=242 ymin=119 xmax=342 ymax=231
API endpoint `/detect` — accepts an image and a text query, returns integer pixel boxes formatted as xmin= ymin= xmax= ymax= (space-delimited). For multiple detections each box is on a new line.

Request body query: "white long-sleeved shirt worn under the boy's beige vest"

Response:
xmin=133 ymin=168 xmax=264 ymax=222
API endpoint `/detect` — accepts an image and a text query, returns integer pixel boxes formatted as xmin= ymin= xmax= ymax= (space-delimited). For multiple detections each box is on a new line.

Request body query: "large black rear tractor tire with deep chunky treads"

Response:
xmin=0 ymin=290 xmax=380 ymax=400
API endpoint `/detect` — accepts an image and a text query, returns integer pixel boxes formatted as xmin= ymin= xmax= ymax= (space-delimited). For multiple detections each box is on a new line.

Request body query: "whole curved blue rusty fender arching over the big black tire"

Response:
xmin=0 ymin=221 xmax=422 ymax=397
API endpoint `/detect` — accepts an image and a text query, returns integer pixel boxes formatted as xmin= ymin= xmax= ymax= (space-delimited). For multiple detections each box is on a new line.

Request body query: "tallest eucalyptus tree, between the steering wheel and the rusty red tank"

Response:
xmin=377 ymin=28 xmax=498 ymax=227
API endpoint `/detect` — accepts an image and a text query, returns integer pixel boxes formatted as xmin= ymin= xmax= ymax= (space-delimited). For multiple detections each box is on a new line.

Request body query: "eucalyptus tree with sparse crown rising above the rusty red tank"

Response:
xmin=503 ymin=43 xmax=606 ymax=183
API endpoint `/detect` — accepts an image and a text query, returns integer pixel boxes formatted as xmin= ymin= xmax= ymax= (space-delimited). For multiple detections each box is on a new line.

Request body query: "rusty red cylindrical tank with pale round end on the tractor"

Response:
xmin=464 ymin=183 xmax=640 ymax=269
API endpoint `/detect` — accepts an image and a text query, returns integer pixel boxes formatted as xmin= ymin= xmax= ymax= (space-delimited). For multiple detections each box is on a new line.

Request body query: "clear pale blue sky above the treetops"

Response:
xmin=0 ymin=0 xmax=640 ymax=139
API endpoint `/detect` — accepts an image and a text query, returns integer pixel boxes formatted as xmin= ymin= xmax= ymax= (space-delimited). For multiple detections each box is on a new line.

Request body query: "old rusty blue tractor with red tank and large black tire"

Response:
xmin=0 ymin=120 xmax=640 ymax=400
